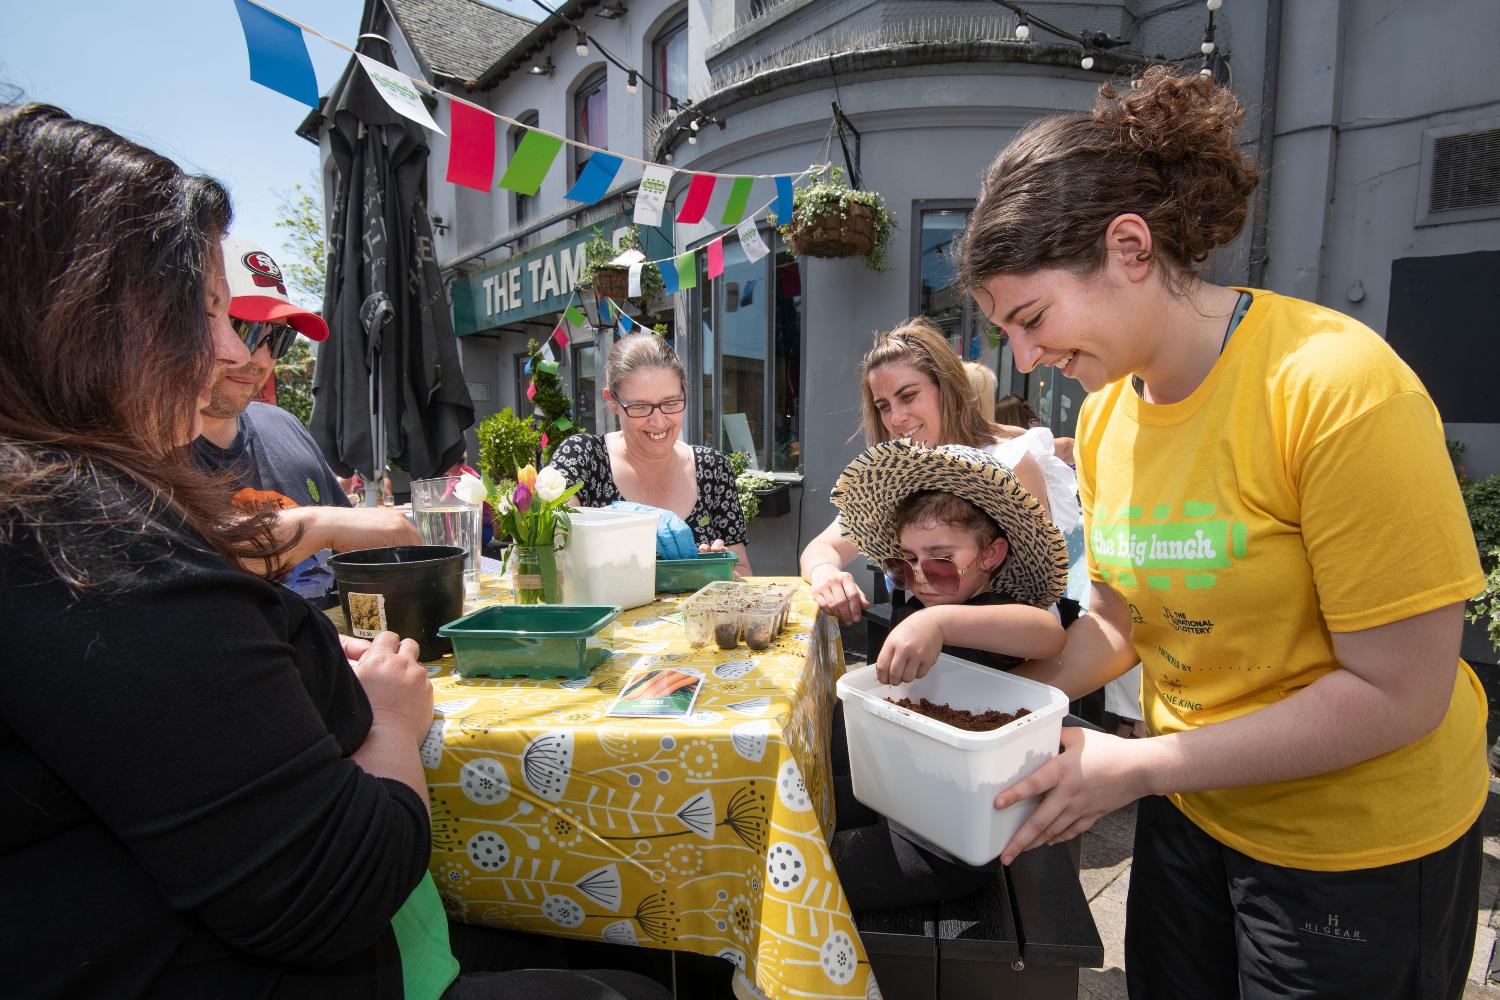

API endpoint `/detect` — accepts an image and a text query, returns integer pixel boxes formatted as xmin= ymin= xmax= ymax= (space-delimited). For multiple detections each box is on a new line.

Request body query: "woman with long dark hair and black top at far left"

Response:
xmin=0 ymin=105 xmax=669 ymax=999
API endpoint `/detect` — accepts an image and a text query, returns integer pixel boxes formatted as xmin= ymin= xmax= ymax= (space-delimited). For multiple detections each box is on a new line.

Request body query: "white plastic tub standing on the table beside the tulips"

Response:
xmin=558 ymin=507 xmax=657 ymax=607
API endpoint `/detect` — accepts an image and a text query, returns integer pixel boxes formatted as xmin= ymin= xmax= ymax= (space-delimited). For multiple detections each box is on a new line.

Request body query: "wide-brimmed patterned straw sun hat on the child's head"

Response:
xmin=833 ymin=439 xmax=1068 ymax=607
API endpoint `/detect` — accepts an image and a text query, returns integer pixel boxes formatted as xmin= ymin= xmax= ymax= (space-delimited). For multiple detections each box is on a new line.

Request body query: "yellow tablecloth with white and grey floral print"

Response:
xmin=422 ymin=580 xmax=879 ymax=1000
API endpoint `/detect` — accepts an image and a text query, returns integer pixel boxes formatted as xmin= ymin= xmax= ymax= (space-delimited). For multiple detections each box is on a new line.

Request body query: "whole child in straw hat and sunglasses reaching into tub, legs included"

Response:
xmin=833 ymin=441 xmax=1068 ymax=910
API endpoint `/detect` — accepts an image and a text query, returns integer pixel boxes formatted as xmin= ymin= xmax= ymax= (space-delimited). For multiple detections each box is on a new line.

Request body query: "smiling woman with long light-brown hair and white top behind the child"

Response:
xmin=801 ymin=316 xmax=1079 ymax=625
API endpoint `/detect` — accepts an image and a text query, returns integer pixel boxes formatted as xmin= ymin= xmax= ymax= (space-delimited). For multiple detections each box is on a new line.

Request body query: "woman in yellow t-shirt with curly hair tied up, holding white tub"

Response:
xmin=959 ymin=67 xmax=1488 ymax=1000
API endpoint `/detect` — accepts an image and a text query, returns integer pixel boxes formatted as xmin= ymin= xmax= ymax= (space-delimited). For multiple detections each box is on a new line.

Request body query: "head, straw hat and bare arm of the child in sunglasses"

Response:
xmin=833 ymin=441 xmax=1068 ymax=684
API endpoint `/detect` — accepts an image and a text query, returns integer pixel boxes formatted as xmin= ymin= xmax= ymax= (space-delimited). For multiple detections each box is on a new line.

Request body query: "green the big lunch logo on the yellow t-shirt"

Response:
xmin=1089 ymin=501 xmax=1248 ymax=591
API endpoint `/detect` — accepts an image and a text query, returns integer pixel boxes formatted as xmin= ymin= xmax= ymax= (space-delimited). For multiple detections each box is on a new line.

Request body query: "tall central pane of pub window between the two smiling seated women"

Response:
xmin=717 ymin=245 xmax=770 ymax=469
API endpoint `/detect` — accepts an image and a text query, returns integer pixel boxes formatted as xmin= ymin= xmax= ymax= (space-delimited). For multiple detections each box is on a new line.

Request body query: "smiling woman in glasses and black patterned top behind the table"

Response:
xmin=552 ymin=333 xmax=752 ymax=576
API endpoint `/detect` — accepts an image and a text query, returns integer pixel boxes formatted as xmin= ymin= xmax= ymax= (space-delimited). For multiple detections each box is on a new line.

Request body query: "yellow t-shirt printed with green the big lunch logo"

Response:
xmin=1074 ymin=289 xmax=1488 ymax=871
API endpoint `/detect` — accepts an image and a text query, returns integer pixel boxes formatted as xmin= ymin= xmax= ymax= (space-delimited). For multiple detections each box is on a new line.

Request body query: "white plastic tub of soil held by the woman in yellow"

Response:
xmin=837 ymin=655 xmax=1068 ymax=865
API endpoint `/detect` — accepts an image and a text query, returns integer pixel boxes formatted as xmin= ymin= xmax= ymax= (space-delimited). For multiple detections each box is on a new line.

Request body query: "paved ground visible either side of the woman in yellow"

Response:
xmin=1079 ymin=778 xmax=1500 ymax=1000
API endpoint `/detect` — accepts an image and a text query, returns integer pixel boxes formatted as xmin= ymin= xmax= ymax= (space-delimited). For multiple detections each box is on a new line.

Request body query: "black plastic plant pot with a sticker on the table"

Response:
xmin=329 ymin=546 xmax=465 ymax=660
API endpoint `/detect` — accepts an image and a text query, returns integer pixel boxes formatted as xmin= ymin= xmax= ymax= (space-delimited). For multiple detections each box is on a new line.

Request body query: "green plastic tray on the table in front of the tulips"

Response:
xmin=438 ymin=604 xmax=620 ymax=678
